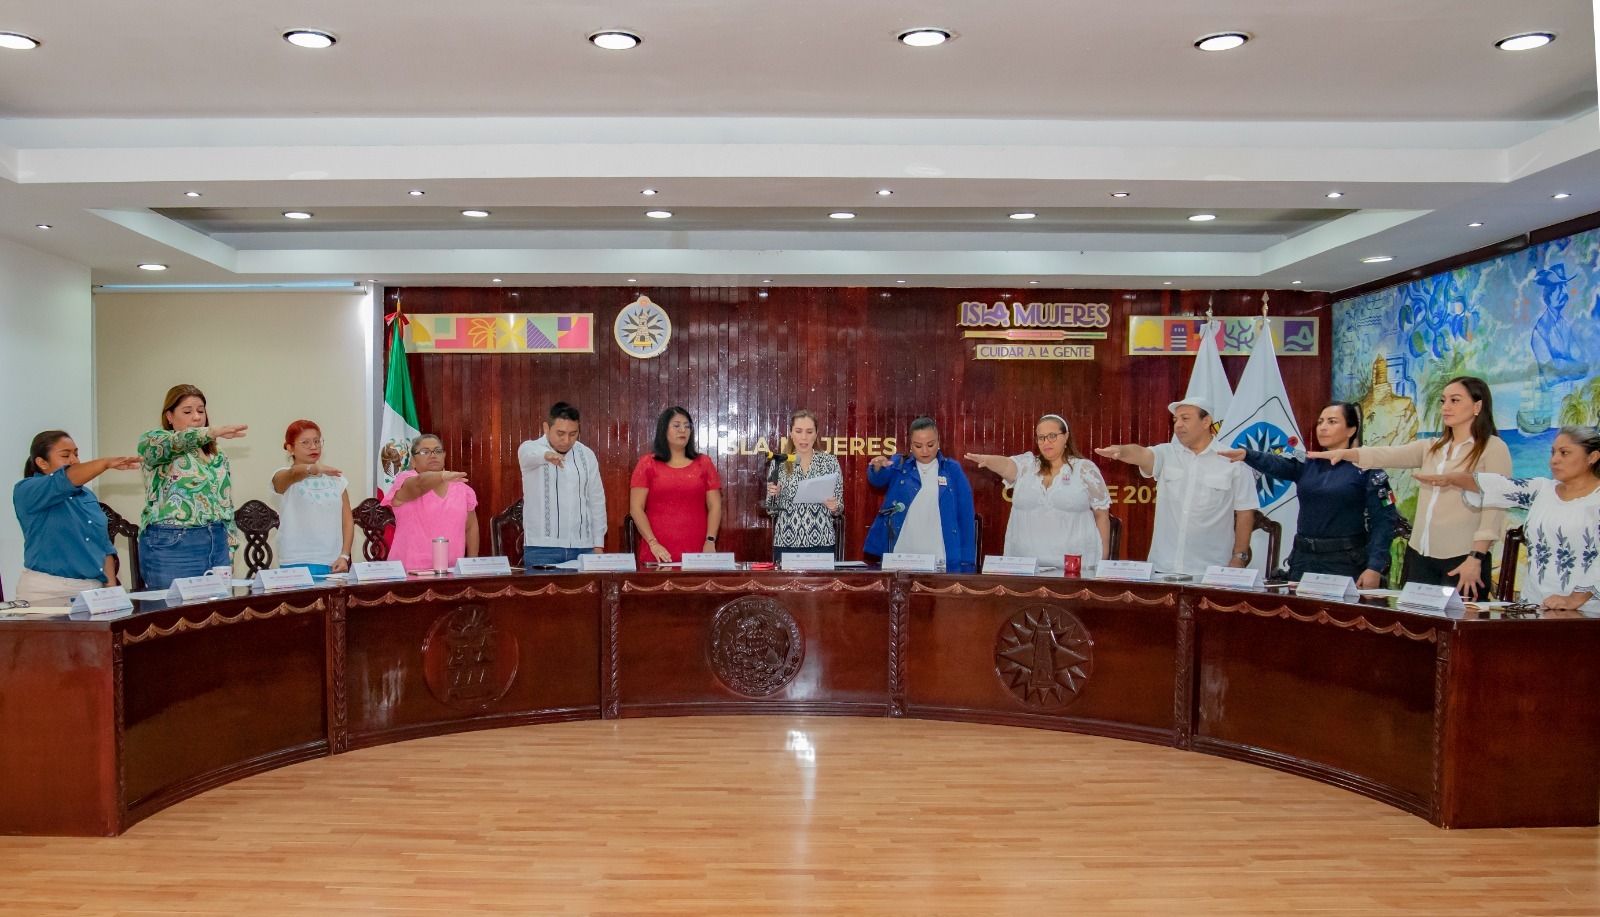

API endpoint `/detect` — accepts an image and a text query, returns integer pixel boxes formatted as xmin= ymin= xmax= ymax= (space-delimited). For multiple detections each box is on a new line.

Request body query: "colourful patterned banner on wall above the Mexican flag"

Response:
xmin=405 ymin=312 xmax=595 ymax=354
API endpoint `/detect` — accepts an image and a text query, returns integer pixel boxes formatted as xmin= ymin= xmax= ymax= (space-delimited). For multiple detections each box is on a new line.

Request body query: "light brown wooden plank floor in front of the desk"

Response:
xmin=0 ymin=717 xmax=1600 ymax=917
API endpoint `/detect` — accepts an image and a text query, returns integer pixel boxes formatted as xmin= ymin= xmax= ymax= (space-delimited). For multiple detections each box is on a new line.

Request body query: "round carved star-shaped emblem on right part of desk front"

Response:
xmin=995 ymin=605 xmax=1094 ymax=711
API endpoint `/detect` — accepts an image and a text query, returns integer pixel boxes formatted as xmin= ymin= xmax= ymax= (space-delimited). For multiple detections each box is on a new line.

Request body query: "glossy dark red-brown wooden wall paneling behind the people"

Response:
xmin=386 ymin=286 xmax=1333 ymax=559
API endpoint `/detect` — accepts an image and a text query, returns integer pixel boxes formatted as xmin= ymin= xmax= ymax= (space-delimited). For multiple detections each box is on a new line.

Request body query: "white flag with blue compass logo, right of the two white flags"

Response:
xmin=1218 ymin=322 xmax=1306 ymax=573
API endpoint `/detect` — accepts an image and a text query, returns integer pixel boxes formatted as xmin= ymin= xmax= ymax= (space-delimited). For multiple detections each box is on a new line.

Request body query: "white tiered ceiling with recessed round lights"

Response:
xmin=0 ymin=0 xmax=1600 ymax=290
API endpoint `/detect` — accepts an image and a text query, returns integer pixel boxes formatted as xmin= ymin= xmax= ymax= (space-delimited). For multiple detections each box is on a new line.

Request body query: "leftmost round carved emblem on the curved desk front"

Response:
xmin=422 ymin=605 xmax=518 ymax=711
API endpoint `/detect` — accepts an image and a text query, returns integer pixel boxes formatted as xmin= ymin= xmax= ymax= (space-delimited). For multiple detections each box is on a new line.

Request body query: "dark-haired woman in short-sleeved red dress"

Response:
xmin=629 ymin=406 xmax=722 ymax=563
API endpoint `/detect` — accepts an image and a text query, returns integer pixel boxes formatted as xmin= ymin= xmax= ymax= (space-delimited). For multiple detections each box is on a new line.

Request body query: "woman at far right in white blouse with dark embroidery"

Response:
xmin=1416 ymin=427 xmax=1600 ymax=613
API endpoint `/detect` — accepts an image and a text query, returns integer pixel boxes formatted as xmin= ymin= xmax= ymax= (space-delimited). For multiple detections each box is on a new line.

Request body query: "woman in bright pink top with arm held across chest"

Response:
xmin=384 ymin=434 xmax=478 ymax=570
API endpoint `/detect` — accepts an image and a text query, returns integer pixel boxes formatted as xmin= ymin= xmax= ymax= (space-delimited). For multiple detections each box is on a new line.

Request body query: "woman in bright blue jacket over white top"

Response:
xmin=862 ymin=418 xmax=978 ymax=571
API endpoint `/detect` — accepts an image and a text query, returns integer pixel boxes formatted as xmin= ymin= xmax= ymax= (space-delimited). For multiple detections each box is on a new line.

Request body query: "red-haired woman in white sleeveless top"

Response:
xmin=272 ymin=421 xmax=355 ymax=576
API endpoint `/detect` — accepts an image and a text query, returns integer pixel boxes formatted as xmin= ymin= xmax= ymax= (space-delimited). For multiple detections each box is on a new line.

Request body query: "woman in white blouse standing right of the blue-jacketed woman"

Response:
xmin=966 ymin=414 xmax=1110 ymax=576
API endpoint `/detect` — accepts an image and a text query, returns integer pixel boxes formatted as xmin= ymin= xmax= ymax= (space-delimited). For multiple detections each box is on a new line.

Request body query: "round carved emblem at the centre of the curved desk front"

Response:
xmin=706 ymin=595 xmax=805 ymax=698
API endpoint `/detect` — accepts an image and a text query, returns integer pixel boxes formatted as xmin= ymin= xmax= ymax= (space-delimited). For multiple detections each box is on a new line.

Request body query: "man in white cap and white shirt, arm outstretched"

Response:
xmin=1094 ymin=397 xmax=1261 ymax=576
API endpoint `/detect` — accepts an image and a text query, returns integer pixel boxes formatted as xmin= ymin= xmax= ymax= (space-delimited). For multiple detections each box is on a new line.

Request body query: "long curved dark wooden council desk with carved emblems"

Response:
xmin=0 ymin=571 xmax=1600 ymax=835
